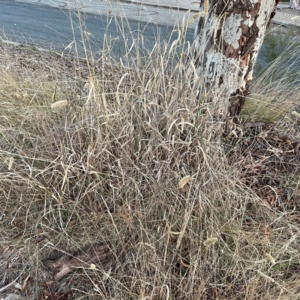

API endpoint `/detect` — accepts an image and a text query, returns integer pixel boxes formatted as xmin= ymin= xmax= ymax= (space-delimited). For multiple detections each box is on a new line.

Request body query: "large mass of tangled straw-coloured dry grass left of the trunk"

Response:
xmin=0 ymin=15 xmax=300 ymax=300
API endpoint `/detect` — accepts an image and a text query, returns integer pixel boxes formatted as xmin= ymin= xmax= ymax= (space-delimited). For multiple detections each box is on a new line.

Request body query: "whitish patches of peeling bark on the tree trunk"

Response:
xmin=194 ymin=0 xmax=275 ymax=115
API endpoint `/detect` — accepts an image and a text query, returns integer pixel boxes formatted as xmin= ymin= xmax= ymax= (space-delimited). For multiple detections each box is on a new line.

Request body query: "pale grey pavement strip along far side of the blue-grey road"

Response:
xmin=14 ymin=0 xmax=300 ymax=28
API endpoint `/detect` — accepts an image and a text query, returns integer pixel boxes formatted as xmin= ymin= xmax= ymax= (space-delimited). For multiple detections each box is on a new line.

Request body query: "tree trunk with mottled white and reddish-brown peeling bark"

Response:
xmin=192 ymin=0 xmax=278 ymax=116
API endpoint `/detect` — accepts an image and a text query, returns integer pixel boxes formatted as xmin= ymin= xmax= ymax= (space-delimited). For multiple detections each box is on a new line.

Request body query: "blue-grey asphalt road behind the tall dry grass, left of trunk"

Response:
xmin=0 ymin=0 xmax=194 ymax=61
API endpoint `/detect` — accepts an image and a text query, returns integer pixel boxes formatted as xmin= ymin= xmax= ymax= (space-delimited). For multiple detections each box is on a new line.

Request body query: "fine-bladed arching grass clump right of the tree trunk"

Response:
xmin=242 ymin=26 xmax=300 ymax=123
